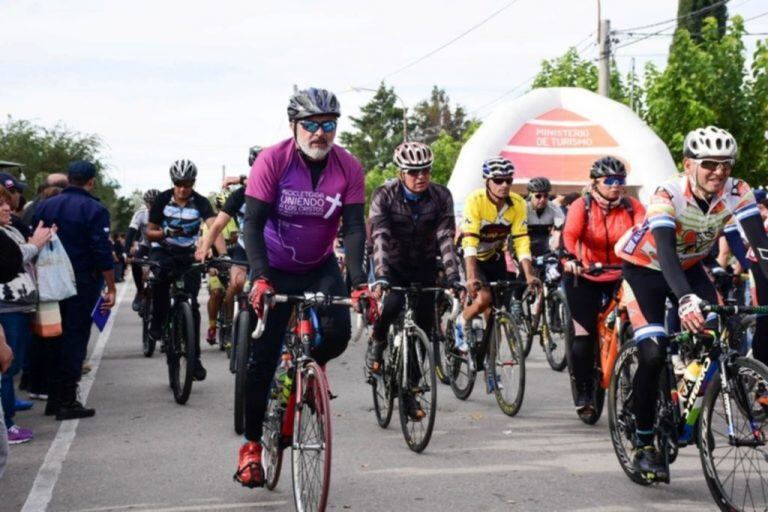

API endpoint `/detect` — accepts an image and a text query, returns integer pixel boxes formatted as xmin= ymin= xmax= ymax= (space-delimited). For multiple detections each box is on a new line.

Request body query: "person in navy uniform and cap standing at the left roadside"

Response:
xmin=34 ymin=160 xmax=115 ymax=420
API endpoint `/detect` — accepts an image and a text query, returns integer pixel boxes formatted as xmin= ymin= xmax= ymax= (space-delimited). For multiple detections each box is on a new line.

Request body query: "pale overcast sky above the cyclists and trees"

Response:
xmin=0 ymin=0 xmax=768 ymax=194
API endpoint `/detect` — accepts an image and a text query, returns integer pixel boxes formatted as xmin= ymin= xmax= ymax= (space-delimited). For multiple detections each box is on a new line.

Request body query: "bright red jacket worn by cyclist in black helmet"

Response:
xmin=563 ymin=197 xmax=645 ymax=282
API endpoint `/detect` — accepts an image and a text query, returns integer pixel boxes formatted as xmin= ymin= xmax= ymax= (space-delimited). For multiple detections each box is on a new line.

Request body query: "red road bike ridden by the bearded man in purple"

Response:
xmin=256 ymin=292 xmax=352 ymax=511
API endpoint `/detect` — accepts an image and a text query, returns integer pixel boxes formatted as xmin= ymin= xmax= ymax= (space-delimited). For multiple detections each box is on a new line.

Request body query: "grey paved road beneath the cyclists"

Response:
xmin=0 ymin=284 xmax=714 ymax=512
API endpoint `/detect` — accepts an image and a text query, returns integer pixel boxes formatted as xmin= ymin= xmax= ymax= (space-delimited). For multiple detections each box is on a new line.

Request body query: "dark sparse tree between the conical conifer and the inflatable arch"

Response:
xmin=408 ymin=85 xmax=470 ymax=144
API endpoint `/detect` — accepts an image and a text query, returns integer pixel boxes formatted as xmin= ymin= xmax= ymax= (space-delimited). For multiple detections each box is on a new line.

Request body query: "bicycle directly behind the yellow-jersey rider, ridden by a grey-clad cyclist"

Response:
xmin=520 ymin=252 xmax=572 ymax=372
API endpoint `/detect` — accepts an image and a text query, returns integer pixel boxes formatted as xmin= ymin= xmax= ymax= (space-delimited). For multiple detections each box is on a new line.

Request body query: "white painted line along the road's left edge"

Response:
xmin=21 ymin=285 xmax=130 ymax=512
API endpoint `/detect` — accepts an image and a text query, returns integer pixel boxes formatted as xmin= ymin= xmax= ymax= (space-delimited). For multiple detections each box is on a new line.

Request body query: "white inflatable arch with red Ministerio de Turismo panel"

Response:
xmin=448 ymin=87 xmax=677 ymax=213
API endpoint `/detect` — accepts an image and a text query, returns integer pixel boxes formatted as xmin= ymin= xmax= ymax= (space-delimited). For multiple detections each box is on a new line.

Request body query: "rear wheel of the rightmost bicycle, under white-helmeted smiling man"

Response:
xmin=608 ymin=344 xmax=651 ymax=485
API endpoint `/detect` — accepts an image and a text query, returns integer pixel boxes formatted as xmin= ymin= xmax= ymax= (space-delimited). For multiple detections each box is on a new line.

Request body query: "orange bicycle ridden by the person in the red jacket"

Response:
xmin=565 ymin=264 xmax=633 ymax=425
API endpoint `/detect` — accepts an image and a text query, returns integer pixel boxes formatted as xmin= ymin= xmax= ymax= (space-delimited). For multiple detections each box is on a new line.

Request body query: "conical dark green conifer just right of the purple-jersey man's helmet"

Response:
xmin=339 ymin=82 xmax=403 ymax=172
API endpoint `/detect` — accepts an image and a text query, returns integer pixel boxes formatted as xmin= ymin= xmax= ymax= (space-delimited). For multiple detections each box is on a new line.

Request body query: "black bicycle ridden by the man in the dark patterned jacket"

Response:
xmin=368 ymin=284 xmax=443 ymax=453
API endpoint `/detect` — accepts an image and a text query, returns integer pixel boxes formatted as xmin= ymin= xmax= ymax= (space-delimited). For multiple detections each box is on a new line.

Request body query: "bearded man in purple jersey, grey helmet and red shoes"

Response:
xmin=235 ymin=88 xmax=370 ymax=487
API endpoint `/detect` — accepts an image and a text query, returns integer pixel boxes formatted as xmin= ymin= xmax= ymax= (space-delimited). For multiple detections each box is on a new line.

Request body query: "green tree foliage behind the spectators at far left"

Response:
xmin=0 ymin=116 xmax=132 ymax=231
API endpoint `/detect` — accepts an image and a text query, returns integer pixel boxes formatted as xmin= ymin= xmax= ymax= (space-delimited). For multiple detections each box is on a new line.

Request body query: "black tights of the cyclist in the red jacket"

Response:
xmin=563 ymin=273 xmax=617 ymax=392
